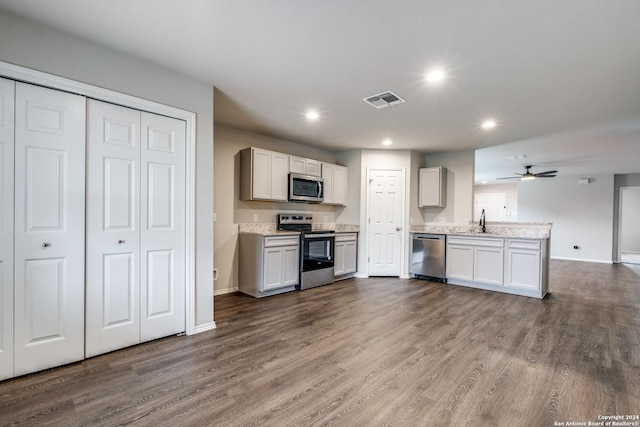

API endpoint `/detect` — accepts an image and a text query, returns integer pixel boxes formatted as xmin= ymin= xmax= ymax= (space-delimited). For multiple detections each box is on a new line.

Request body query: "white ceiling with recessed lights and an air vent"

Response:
xmin=0 ymin=0 xmax=640 ymax=181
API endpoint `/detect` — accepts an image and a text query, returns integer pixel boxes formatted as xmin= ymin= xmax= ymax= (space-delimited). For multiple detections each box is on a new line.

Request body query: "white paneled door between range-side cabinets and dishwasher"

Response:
xmin=368 ymin=169 xmax=404 ymax=276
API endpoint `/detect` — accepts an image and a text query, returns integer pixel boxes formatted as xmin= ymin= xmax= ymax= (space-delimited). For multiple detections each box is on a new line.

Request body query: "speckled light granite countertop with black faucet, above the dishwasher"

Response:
xmin=411 ymin=222 xmax=551 ymax=239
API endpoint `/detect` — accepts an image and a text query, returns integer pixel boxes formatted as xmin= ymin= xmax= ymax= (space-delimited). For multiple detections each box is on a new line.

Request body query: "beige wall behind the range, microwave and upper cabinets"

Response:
xmin=214 ymin=125 xmax=342 ymax=294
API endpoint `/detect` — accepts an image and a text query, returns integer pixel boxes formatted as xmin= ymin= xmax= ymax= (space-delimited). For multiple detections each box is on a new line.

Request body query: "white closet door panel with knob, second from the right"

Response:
xmin=86 ymin=100 xmax=140 ymax=357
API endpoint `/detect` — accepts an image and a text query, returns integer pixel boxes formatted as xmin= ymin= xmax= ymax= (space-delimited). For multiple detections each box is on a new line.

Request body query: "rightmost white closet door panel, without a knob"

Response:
xmin=140 ymin=113 xmax=186 ymax=341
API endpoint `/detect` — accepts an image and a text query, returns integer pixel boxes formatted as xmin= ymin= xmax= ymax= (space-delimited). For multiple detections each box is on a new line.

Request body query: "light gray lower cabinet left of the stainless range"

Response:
xmin=238 ymin=234 xmax=300 ymax=298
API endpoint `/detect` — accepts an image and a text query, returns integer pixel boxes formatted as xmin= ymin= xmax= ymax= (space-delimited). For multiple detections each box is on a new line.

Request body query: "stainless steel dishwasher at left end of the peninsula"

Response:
xmin=411 ymin=233 xmax=447 ymax=282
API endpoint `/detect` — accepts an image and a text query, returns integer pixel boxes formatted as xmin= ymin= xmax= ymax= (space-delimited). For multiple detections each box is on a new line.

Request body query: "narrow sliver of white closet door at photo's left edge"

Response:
xmin=0 ymin=78 xmax=15 ymax=380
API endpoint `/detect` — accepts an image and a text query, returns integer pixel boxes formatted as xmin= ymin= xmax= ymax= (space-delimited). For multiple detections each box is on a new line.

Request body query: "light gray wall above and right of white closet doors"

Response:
xmin=0 ymin=11 xmax=218 ymax=328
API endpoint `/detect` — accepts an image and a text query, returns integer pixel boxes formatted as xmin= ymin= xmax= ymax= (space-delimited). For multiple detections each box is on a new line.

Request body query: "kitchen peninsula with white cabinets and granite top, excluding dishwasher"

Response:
xmin=411 ymin=223 xmax=551 ymax=299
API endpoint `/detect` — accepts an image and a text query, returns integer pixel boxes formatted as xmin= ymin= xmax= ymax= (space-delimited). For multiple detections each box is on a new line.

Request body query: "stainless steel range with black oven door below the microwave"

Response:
xmin=278 ymin=214 xmax=336 ymax=290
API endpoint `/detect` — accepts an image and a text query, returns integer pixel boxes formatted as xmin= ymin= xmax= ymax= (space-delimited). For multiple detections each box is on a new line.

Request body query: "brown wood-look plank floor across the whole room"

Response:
xmin=0 ymin=261 xmax=640 ymax=427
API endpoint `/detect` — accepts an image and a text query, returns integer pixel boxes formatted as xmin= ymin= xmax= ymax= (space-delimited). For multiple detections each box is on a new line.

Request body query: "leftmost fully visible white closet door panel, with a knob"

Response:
xmin=14 ymin=83 xmax=86 ymax=375
